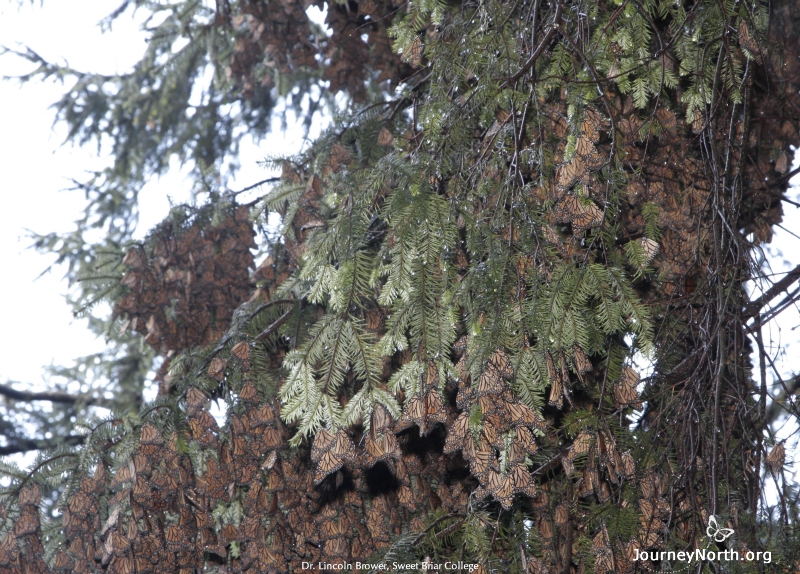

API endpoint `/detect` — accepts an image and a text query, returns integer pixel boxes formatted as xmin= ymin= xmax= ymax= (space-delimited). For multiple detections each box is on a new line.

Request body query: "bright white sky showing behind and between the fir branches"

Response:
xmin=0 ymin=0 xmax=800 ymax=504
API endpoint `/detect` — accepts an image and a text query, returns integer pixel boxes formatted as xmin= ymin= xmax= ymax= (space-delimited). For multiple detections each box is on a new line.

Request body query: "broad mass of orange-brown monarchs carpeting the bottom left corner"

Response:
xmin=0 ymin=374 xmax=469 ymax=574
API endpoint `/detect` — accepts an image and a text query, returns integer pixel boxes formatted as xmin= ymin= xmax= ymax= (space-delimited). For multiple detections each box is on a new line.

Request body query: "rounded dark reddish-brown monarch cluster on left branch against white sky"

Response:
xmin=114 ymin=207 xmax=255 ymax=354
